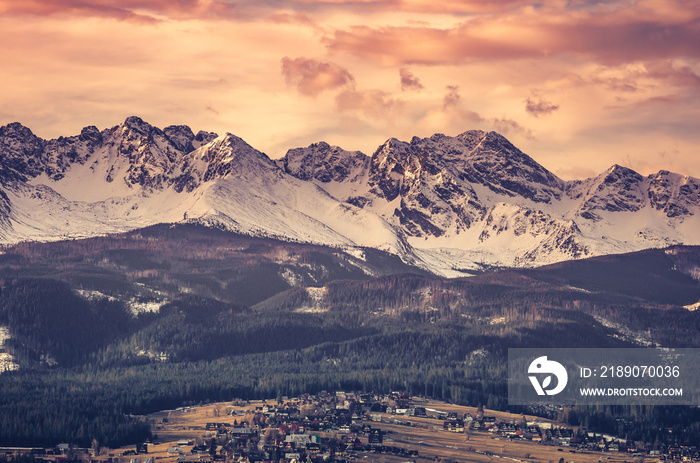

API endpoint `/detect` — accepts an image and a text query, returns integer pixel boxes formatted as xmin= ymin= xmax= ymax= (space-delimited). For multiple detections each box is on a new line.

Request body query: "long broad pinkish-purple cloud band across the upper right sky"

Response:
xmin=326 ymin=0 xmax=700 ymax=66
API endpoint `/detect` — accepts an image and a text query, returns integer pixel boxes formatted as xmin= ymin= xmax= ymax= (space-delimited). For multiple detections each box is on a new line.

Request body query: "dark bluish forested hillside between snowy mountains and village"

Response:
xmin=0 ymin=226 xmax=700 ymax=445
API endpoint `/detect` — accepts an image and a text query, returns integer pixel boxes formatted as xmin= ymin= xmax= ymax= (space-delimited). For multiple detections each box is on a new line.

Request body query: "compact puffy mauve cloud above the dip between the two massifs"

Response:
xmin=282 ymin=56 xmax=355 ymax=97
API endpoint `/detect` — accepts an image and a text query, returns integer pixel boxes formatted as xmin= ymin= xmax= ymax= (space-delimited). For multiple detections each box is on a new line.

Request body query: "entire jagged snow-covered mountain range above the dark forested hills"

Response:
xmin=0 ymin=117 xmax=700 ymax=277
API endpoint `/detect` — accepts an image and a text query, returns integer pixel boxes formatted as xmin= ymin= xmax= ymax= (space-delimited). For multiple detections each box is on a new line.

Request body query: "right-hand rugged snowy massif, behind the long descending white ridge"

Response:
xmin=280 ymin=131 xmax=700 ymax=276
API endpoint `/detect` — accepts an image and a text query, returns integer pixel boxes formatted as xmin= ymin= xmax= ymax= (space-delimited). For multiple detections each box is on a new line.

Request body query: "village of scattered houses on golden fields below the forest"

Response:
xmin=5 ymin=392 xmax=700 ymax=463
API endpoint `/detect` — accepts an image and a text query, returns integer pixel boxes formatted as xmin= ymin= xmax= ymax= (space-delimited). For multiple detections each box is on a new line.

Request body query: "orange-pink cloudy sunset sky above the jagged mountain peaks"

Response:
xmin=0 ymin=0 xmax=700 ymax=180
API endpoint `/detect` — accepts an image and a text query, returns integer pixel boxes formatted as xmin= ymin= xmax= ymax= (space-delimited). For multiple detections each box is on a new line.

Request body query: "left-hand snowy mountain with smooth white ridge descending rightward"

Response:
xmin=2 ymin=118 xmax=404 ymax=264
